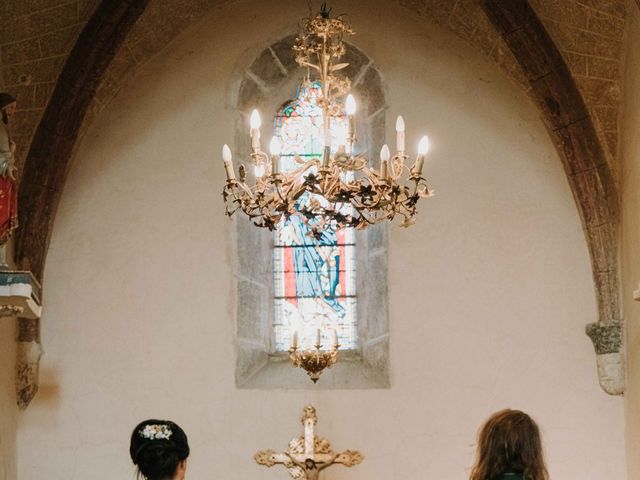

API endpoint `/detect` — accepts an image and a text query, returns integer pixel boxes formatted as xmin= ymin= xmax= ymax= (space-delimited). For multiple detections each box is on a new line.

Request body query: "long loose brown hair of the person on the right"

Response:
xmin=469 ymin=409 xmax=549 ymax=480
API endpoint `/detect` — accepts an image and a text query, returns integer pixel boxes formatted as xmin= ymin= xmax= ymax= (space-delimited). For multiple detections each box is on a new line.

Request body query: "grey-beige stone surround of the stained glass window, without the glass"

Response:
xmin=231 ymin=35 xmax=390 ymax=389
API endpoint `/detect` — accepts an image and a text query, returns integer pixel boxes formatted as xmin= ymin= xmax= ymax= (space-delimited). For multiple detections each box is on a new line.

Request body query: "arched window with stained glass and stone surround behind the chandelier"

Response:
xmin=235 ymin=35 xmax=390 ymax=389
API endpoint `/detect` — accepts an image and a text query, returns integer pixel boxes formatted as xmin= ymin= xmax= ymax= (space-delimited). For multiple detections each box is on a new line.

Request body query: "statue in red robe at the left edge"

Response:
xmin=0 ymin=93 xmax=18 ymax=253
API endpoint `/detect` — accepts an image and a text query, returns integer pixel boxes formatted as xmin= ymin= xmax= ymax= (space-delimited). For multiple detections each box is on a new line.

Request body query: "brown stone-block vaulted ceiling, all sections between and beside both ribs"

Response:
xmin=0 ymin=0 xmax=640 ymax=184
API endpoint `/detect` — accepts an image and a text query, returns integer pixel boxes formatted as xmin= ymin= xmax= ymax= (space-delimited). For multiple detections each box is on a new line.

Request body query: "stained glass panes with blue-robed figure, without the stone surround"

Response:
xmin=273 ymin=82 xmax=358 ymax=351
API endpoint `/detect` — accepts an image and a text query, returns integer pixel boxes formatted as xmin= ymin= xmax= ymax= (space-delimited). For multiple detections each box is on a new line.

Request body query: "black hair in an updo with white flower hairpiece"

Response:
xmin=129 ymin=419 xmax=189 ymax=480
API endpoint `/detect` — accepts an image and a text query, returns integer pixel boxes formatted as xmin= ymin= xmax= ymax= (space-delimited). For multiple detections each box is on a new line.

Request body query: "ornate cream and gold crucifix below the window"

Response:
xmin=253 ymin=405 xmax=364 ymax=480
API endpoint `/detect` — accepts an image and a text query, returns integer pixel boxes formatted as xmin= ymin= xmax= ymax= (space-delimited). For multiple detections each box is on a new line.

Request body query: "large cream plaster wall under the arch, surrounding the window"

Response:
xmin=18 ymin=0 xmax=626 ymax=480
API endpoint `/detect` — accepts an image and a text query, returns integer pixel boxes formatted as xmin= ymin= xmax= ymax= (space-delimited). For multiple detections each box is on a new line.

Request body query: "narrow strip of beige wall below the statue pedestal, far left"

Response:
xmin=0 ymin=317 xmax=18 ymax=480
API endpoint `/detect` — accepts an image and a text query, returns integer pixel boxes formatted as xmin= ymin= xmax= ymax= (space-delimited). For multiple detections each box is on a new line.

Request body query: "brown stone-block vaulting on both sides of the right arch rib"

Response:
xmin=394 ymin=0 xmax=627 ymax=180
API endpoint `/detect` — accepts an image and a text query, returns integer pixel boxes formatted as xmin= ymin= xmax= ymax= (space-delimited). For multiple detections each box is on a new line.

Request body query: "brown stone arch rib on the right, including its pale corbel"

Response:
xmin=482 ymin=0 xmax=624 ymax=395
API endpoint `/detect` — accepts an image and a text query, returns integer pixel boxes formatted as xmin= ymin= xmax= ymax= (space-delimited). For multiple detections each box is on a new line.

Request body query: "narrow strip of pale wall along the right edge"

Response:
xmin=622 ymin=2 xmax=640 ymax=480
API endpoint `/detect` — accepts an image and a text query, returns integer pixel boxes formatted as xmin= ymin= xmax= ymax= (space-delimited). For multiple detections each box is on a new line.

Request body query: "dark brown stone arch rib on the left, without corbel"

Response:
xmin=15 ymin=0 xmax=149 ymax=281
